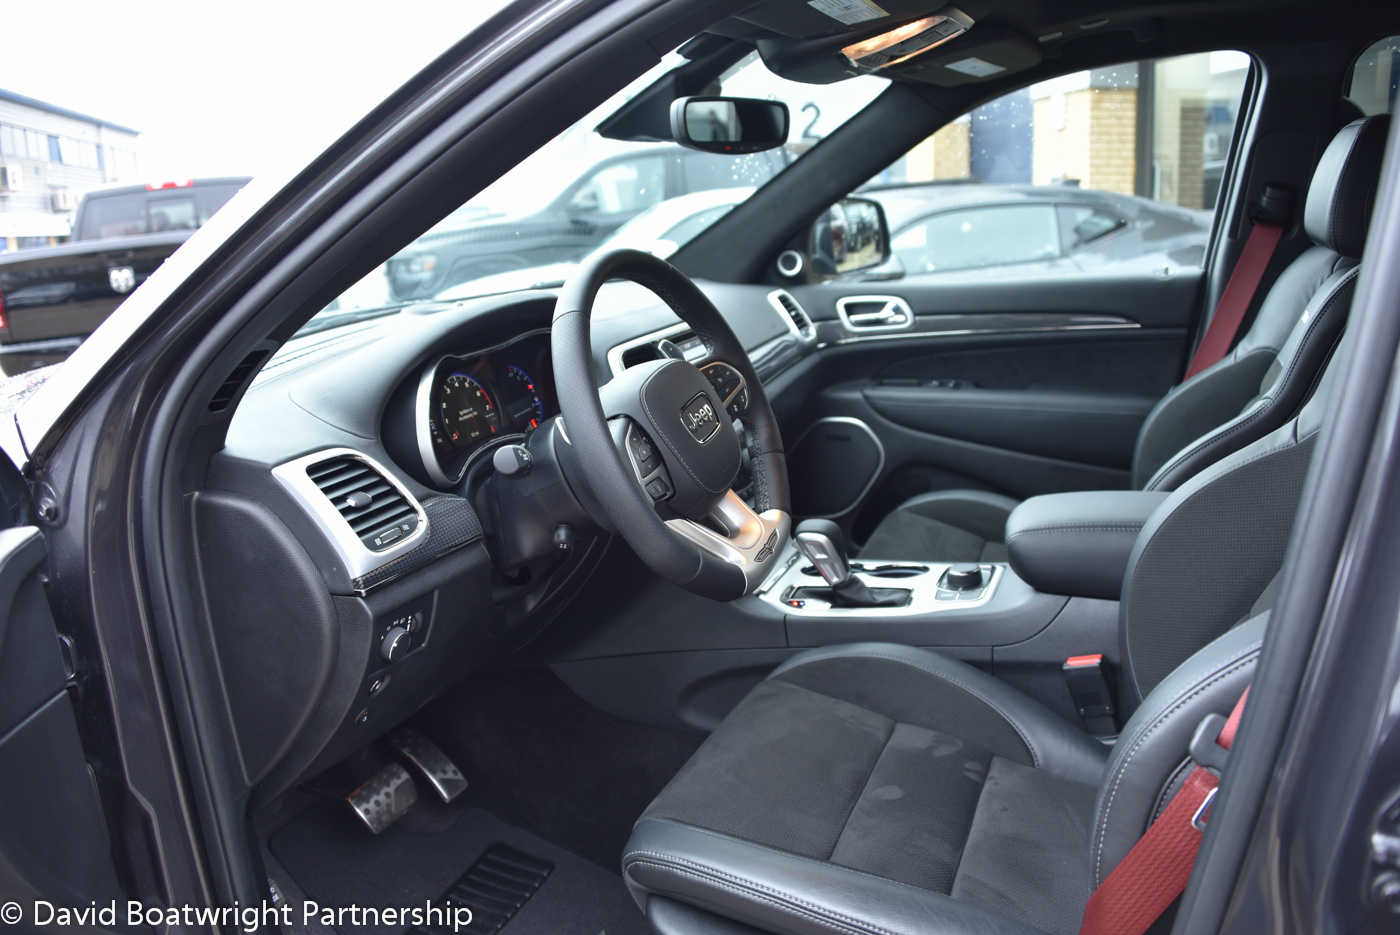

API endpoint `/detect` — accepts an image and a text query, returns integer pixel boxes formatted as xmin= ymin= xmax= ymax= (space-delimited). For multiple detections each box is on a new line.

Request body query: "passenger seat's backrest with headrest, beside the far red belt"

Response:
xmin=1133 ymin=113 xmax=1390 ymax=490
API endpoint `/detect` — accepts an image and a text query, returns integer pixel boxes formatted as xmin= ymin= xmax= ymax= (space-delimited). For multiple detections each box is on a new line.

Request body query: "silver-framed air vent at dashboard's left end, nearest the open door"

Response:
xmin=272 ymin=448 xmax=428 ymax=578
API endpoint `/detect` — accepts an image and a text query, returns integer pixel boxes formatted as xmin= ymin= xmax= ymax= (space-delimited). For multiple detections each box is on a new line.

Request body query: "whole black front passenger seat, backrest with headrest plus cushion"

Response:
xmin=861 ymin=113 xmax=1390 ymax=561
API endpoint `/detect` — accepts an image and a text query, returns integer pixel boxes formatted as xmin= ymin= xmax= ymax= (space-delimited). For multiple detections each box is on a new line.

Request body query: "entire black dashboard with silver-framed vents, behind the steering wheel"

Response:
xmin=204 ymin=283 xmax=816 ymax=802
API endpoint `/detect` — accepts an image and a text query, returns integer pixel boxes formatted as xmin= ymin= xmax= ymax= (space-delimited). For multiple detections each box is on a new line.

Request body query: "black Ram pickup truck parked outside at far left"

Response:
xmin=0 ymin=178 xmax=248 ymax=375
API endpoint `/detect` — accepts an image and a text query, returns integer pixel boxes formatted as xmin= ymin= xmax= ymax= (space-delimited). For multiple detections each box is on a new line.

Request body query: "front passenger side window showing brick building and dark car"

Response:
xmin=861 ymin=50 xmax=1254 ymax=274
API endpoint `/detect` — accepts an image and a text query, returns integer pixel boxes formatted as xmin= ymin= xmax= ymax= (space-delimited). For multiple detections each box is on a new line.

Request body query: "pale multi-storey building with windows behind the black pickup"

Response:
xmin=0 ymin=90 xmax=139 ymax=251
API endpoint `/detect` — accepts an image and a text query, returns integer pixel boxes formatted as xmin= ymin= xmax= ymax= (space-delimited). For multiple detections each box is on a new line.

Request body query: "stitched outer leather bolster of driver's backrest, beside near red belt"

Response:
xmin=1089 ymin=613 xmax=1268 ymax=886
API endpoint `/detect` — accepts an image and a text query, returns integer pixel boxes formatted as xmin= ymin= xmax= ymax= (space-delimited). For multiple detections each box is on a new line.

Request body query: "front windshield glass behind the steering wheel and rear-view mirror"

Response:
xmin=302 ymin=53 xmax=888 ymax=332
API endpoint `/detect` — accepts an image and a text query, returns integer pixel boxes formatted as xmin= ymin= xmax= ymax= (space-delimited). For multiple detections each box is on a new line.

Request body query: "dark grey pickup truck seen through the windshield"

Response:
xmin=385 ymin=147 xmax=788 ymax=298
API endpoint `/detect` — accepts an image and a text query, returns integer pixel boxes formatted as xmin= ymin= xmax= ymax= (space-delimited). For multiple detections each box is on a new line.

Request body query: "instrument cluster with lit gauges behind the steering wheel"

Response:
xmin=417 ymin=330 xmax=559 ymax=487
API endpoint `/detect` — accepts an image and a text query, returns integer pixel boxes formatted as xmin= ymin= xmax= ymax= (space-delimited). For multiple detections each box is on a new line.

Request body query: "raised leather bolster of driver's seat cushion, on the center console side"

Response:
xmin=769 ymin=642 xmax=1107 ymax=785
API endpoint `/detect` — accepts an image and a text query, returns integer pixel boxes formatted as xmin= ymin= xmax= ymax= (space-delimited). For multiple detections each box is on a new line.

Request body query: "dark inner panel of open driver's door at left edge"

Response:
xmin=0 ymin=529 xmax=120 ymax=907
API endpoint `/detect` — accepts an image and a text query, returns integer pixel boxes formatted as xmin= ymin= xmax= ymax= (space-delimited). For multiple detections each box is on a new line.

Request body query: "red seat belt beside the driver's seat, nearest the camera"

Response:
xmin=1079 ymin=689 xmax=1249 ymax=935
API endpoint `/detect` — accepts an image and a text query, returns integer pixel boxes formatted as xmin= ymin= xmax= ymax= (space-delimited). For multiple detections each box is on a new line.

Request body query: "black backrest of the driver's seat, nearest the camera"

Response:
xmin=1089 ymin=330 xmax=1347 ymax=886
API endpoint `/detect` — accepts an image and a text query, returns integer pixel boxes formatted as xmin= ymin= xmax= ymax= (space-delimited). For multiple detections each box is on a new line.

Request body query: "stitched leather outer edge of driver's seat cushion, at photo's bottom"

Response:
xmin=622 ymin=819 xmax=1036 ymax=935
